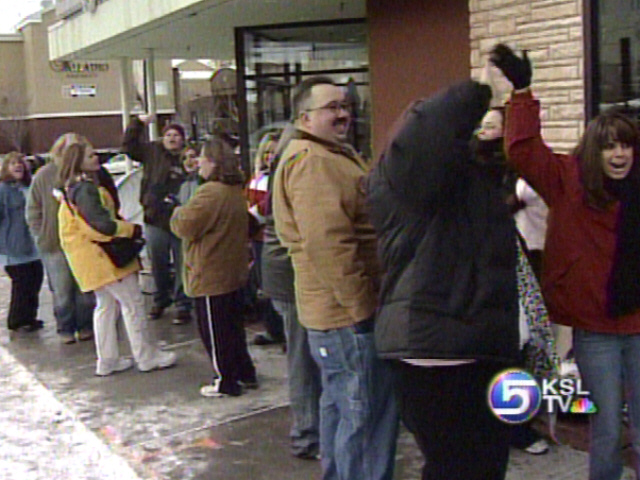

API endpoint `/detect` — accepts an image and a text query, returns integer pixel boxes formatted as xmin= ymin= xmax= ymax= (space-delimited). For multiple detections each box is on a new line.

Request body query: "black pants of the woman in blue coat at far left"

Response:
xmin=4 ymin=260 xmax=44 ymax=330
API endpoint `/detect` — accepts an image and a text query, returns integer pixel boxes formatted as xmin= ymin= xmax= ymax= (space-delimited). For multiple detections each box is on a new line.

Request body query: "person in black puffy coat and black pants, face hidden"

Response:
xmin=368 ymin=77 xmax=519 ymax=480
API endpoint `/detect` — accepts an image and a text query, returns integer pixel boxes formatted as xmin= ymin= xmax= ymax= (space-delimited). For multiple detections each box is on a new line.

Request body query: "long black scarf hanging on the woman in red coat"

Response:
xmin=605 ymin=173 xmax=640 ymax=318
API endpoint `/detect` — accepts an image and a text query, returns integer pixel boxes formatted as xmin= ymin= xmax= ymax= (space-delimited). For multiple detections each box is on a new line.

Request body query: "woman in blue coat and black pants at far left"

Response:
xmin=0 ymin=152 xmax=44 ymax=332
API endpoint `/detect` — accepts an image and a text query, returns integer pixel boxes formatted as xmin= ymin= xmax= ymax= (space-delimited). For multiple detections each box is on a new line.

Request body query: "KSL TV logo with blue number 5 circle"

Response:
xmin=487 ymin=368 xmax=598 ymax=423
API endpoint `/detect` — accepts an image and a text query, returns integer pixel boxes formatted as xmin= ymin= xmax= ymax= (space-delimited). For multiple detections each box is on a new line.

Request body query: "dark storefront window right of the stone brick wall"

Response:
xmin=591 ymin=0 xmax=640 ymax=118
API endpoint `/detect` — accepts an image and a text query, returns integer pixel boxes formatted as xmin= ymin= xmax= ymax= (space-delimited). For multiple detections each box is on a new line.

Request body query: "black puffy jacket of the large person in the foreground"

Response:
xmin=368 ymin=81 xmax=518 ymax=362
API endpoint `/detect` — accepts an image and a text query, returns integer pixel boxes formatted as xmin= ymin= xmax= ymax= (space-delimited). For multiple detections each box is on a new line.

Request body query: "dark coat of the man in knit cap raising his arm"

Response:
xmin=122 ymin=119 xmax=187 ymax=231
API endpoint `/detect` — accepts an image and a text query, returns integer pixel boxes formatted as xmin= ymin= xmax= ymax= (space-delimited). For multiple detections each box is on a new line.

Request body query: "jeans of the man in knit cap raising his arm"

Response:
xmin=144 ymin=224 xmax=192 ymax=311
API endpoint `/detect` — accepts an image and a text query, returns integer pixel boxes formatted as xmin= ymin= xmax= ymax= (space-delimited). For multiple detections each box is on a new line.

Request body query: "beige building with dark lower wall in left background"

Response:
xmin=0 ymin=8 xmax=175 ymax=153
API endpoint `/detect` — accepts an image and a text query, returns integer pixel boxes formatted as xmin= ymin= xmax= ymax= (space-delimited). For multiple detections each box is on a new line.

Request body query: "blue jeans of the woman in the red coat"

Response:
xmin=573 ymin=329 xmax=640 ymax=480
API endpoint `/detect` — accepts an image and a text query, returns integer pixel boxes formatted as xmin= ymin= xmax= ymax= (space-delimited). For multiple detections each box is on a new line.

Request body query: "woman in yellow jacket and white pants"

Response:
xmin=58 ymin=137 xmax=176 ymax=376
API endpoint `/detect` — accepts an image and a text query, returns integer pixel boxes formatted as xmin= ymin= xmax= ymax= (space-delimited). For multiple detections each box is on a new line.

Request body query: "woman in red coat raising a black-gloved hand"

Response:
xmin=491 ymin=45 xmax=640 ymax=480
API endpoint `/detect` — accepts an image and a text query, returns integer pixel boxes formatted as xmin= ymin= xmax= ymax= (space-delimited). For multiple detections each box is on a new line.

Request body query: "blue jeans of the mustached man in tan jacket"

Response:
xmin=307 ymin=326 xmax=399 ymax=480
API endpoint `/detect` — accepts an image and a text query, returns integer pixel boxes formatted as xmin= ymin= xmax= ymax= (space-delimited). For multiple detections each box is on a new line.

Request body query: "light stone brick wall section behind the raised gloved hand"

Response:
xmin=469 ymin=0 xmax=585 ymax=151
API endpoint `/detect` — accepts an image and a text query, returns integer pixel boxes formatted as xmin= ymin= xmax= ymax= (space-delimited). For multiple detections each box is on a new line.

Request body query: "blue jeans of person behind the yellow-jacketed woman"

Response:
xmin=40 ymin=251 xmax=96 ymax=335
